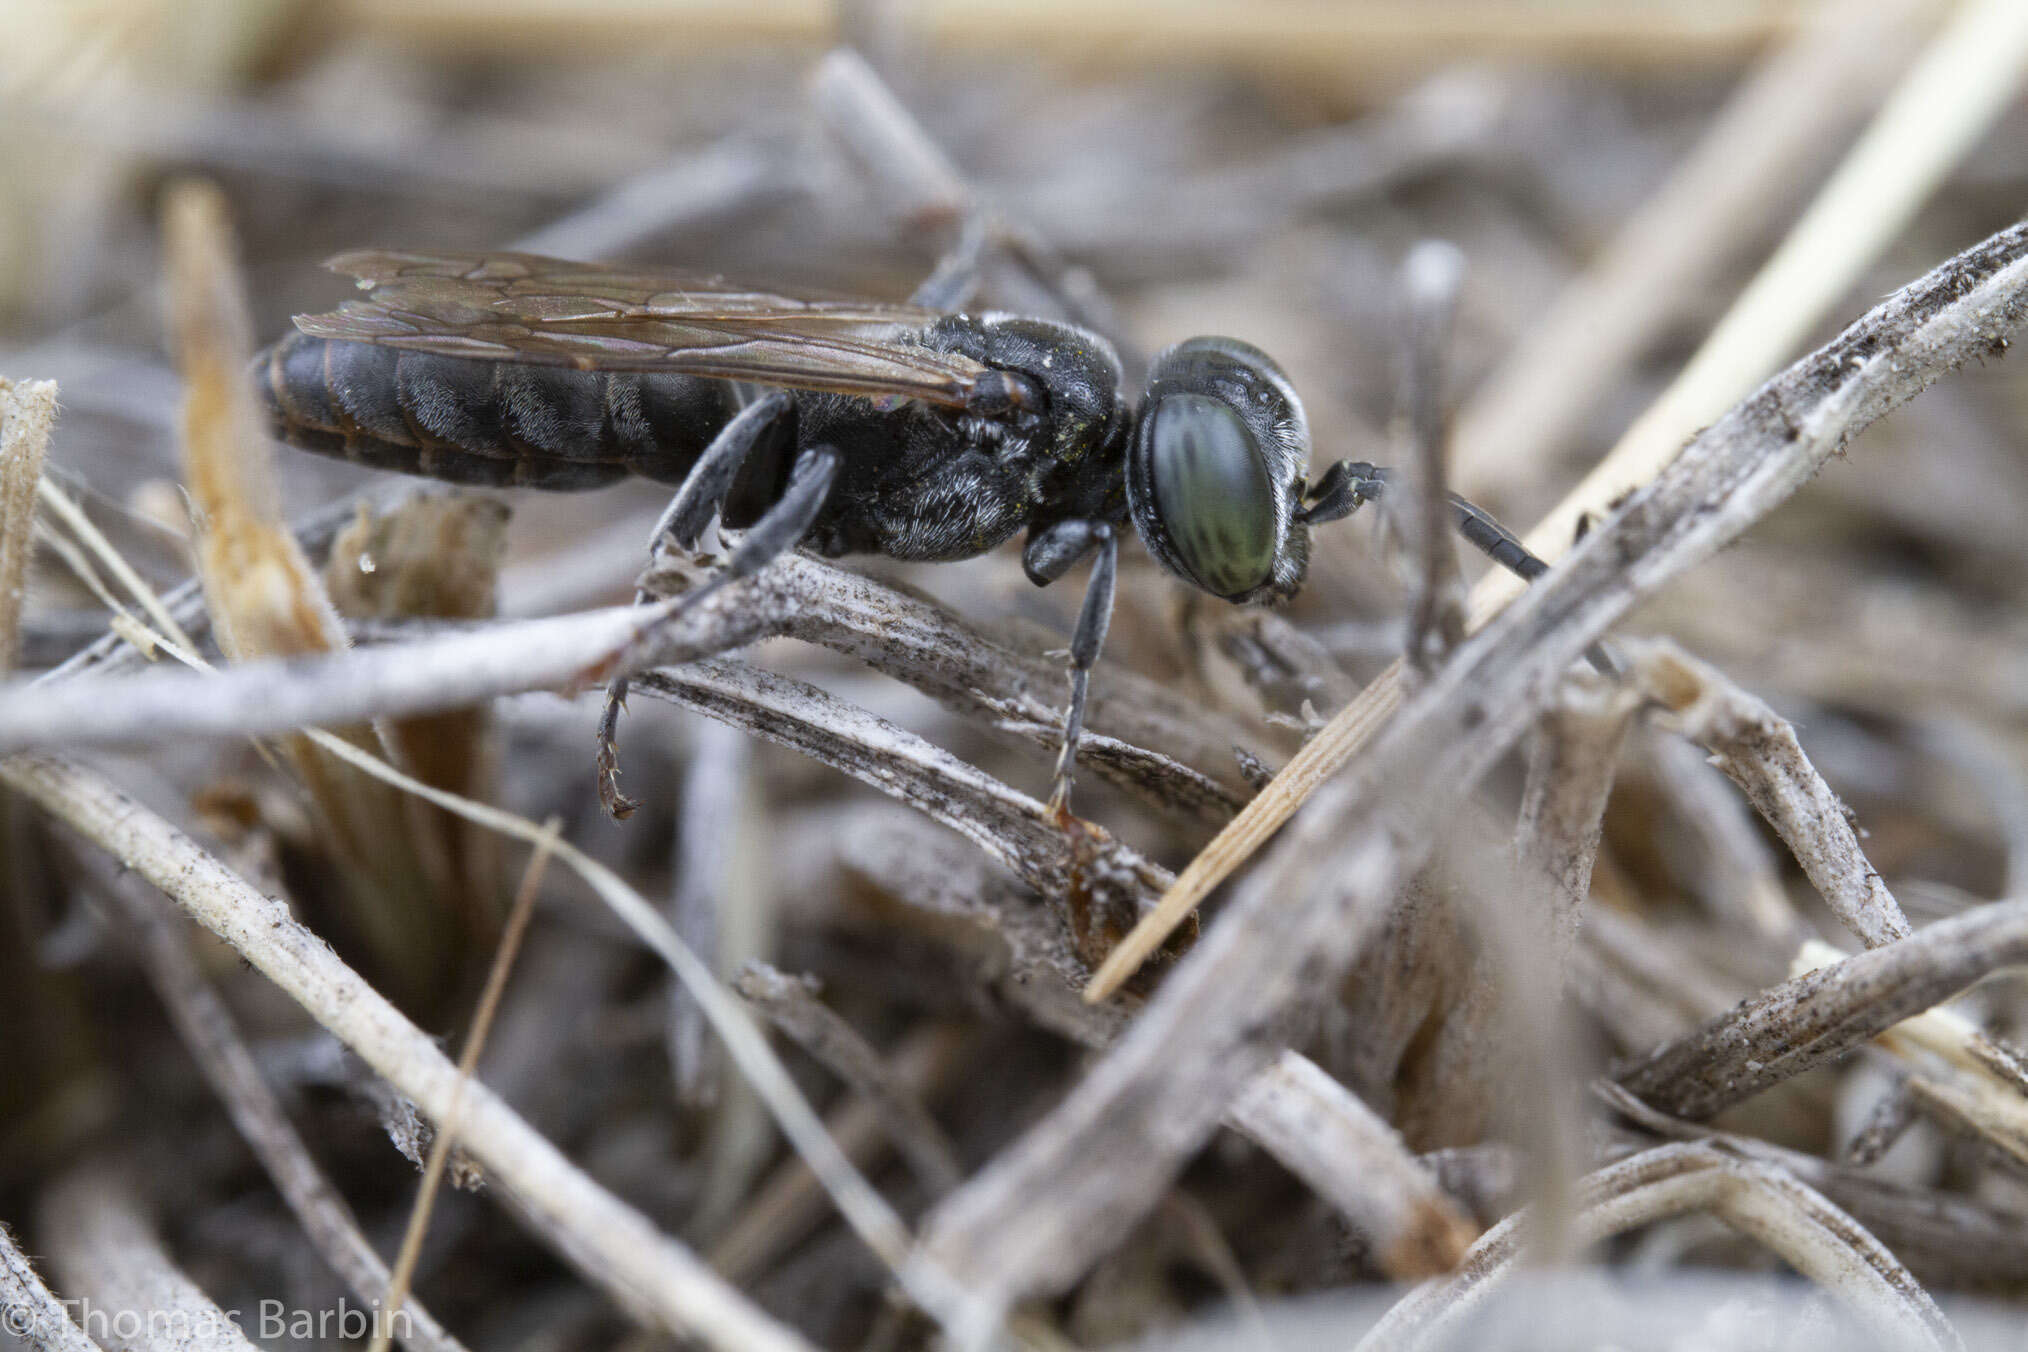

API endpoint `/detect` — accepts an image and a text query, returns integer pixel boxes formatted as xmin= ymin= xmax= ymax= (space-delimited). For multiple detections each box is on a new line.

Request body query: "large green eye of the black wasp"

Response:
xmin=1148 ymin=393 xmax=1278 ymax=596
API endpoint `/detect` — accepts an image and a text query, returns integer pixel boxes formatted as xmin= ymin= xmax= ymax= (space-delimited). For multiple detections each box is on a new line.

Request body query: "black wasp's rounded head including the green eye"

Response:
xmin=1128 ymin=339 xmax=1310 ymax=602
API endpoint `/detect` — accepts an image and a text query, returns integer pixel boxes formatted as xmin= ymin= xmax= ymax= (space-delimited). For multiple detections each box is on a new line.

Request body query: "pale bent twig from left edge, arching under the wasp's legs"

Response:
xmin=0 ymin=555 xmax=1259 ymax=821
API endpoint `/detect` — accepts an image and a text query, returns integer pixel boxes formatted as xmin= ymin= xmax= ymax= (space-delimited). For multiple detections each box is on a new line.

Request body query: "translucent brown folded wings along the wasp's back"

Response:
xmin=296 ymin=249 xmax=986 ymax=407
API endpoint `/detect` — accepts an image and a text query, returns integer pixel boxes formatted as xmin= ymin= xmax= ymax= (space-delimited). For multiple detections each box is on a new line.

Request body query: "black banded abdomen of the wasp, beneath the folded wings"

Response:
xmin=254 ymin=332 xmax=736 ymax=489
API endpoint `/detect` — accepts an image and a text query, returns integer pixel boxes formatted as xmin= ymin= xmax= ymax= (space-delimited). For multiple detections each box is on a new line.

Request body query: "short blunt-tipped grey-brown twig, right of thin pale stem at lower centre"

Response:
xmin=732 ymin=963 xmax=965 ymax=1196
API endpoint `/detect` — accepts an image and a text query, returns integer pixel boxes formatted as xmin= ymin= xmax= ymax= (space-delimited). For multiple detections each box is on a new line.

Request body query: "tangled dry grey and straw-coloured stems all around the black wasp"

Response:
xmin=0 ymin=0 xmax=2028 ymax=1352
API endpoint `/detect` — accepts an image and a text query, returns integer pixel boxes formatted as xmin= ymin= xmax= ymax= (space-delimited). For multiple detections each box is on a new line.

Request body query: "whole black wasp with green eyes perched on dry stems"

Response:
xmin=256 ymin=249 xmax=1545 ymax=811
